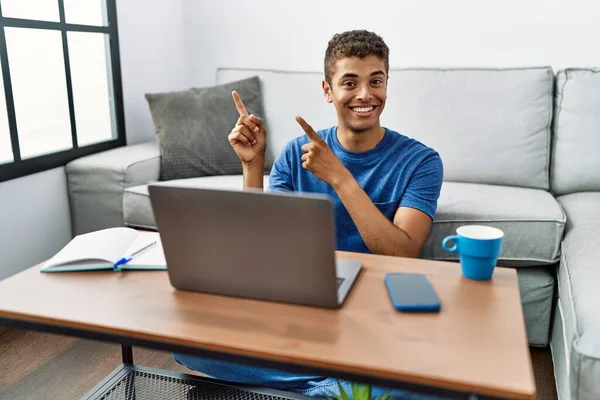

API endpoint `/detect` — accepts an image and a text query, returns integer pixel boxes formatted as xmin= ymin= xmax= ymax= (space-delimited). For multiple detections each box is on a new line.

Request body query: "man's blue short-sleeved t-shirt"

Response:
xmin=267 ymin=127 xmax=443 ymax=253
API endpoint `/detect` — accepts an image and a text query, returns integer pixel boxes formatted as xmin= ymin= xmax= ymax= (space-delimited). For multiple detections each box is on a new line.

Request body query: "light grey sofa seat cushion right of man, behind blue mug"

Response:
xmin=422 ymin=182 xmax=566 ymax=266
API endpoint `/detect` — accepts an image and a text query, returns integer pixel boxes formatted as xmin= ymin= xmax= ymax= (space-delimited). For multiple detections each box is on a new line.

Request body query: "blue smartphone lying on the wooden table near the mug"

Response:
xmin=384 ymin=273 xmax=441 ymax=312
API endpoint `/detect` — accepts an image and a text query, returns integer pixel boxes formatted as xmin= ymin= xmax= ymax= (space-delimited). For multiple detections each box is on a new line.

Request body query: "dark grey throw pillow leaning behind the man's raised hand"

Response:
xmin=146 ymin=76 xmax=272 ymax=181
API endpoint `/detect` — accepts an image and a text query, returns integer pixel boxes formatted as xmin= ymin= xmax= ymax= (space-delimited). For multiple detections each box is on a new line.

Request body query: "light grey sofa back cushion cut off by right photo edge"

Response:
xmin=551 ymin=69 xmax=600 ymax=195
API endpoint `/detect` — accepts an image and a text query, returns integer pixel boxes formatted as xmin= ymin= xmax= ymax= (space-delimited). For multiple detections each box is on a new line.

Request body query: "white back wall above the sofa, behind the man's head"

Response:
xmin=184 ymin=0 xmax=600 ymax=85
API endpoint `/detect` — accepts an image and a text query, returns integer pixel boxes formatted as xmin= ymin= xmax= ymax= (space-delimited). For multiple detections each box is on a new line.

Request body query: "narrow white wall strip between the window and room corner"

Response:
xmin=117 ymin=0 xmax=187 ymax=144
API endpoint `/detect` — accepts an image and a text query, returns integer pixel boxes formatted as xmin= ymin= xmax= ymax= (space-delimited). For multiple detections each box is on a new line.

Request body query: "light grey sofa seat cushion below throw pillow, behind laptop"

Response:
xmin=123 ymin=175 xmax=269 ymax=229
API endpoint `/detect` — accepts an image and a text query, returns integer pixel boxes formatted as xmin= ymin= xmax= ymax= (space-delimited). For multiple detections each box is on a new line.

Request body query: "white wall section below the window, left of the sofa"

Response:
xmin=0 ymin=167 xmax=71 ymax=280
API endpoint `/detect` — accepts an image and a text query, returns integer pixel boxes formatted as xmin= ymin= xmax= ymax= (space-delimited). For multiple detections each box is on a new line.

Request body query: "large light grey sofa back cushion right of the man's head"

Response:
xmin=382 ymin=67 xmax=554 ymax=189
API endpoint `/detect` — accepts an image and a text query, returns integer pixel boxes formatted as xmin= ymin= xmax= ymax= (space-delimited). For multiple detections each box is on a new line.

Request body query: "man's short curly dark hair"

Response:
xmin=325 ymin=30 xmax=390 ymax=83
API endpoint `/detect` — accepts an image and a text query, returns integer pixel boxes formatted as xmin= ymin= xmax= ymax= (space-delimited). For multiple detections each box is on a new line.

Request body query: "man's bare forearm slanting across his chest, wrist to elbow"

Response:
xmin=333 ymin=176 xmax=419 ymax=257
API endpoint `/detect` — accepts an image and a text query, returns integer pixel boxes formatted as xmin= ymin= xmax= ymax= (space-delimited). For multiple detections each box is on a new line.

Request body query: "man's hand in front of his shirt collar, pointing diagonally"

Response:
xmin=296 ymin=116 xmax=352 ymax=188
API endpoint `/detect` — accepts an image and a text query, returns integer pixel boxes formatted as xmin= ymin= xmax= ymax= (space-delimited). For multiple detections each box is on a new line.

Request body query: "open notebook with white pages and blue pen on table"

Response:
xmin=41 ymin=228 xmax=167 ymax=272
